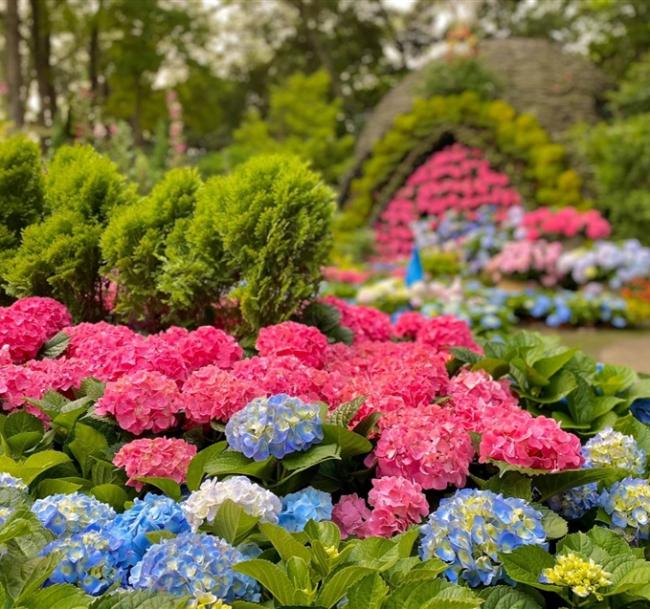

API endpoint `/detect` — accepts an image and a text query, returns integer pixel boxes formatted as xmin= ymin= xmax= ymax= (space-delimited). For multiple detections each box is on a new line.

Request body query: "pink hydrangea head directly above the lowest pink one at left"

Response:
xmin=95 ymin=370 xmax=182 ymax=435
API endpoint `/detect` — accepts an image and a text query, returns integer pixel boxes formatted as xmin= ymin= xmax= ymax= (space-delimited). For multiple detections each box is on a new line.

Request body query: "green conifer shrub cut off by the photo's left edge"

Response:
xmin=0 ymin=136 xmax=43 ymax=252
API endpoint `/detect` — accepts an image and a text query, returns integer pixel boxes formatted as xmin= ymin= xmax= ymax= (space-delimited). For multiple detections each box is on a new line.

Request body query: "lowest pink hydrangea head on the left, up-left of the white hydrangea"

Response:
xmin=113 ymin=437 xmax=196 ymax=491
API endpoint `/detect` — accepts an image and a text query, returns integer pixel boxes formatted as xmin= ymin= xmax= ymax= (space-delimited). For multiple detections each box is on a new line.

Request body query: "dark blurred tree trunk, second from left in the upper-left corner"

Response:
xmin=30 ymin=0 xmax=56 ymax=126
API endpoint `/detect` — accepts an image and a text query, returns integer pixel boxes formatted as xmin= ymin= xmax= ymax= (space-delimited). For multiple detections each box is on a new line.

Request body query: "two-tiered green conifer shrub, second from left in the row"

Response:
xmin=3 ymin=146 xmax=135 ymax=319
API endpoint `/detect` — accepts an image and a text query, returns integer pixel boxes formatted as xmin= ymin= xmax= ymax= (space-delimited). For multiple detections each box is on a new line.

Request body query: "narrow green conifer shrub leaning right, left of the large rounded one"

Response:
xmin=101 ymin=168 xmax=202 ymax=321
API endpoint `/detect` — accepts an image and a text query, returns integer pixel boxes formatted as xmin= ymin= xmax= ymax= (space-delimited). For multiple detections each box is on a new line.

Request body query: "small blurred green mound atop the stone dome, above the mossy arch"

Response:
xmin=422 ymin=57 xmax=501 ymax=99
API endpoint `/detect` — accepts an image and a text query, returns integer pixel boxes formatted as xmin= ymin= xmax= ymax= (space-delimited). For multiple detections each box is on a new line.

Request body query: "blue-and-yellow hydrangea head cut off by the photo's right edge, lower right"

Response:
xmin=600 ymin=478 xmax=650 ymax=541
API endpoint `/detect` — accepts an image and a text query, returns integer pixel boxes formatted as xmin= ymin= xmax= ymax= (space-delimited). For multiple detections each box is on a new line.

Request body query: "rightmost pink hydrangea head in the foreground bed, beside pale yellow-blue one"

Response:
xmin=480 ymin=410 xmax=584 ymax=472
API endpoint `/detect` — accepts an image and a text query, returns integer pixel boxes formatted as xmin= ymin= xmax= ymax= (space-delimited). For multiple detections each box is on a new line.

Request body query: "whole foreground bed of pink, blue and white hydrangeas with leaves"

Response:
xmin=0 ymin=297 xmax=650 ymax=609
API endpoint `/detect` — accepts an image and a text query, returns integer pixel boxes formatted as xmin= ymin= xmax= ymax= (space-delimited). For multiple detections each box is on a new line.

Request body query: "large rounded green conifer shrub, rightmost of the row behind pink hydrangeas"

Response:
xmin=213 ymin=156 xmax=334 ymax=328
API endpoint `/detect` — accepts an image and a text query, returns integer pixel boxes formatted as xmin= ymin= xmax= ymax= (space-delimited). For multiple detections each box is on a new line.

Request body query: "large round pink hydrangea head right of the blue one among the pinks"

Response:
xmin=366 ymin=406 xmax=474 ymax=490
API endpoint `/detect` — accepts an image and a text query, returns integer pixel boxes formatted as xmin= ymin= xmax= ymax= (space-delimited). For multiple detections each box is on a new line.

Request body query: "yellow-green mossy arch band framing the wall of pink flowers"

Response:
xmin=340 ymin=92 xmax=590 ymax=229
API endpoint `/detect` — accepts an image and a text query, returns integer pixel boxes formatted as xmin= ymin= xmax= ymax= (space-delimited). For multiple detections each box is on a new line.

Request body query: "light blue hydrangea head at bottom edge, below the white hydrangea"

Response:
xmin=129 ymin=533 xmax=260 ymax=601
